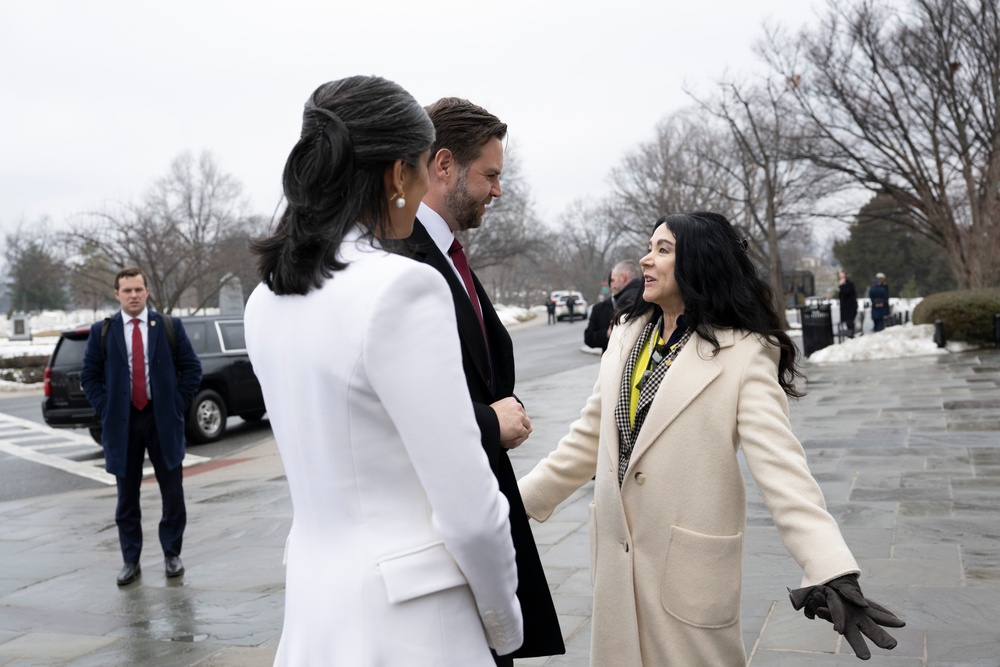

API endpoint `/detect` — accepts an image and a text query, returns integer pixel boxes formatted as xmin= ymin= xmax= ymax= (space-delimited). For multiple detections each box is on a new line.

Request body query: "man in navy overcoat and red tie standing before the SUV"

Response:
xmin=80 ymin=267 xmax=201 ymax=586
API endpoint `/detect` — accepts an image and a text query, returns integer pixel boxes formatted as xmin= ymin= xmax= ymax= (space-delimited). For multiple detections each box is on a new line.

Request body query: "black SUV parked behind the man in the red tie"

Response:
xmin=42 ymin=315 xmax=264 ymax=443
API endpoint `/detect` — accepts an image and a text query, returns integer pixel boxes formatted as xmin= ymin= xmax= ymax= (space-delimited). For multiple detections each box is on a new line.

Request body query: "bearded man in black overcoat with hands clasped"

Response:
xmin=404 ymin=98 xmax=566 ymax=665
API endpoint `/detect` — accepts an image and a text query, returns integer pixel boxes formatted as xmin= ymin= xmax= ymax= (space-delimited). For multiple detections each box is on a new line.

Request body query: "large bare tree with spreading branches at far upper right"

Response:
xmin=764 ymin=0 xmax=1000 ymax=288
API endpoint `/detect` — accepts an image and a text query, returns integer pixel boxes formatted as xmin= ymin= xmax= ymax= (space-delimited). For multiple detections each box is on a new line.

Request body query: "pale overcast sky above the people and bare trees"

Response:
xmin=0 ymin=0 xmax=823 ymax=237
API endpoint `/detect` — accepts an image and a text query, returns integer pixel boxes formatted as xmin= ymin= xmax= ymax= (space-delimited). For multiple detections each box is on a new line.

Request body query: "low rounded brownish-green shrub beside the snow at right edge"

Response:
xmin=913 ymin=288 xmax=1000 ymax=346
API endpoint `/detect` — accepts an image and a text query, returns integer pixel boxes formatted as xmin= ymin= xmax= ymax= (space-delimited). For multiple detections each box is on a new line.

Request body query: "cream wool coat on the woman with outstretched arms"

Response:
xmin=520 ymin=320 xmax=859 ymax=667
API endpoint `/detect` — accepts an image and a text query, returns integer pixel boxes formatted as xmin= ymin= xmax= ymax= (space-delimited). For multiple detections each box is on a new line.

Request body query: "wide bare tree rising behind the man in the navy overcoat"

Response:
xmin=63 ymin=153 xmax=251 ymax=313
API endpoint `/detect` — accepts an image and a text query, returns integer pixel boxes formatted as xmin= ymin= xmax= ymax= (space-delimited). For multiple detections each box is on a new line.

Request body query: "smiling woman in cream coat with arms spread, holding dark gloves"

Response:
xmin=519 ymin=213 xmax=902 ymax=667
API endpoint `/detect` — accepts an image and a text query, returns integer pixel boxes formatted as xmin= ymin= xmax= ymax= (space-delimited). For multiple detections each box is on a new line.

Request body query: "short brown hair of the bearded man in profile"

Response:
xmin=425 ymin=97 xmax=507 ymax=167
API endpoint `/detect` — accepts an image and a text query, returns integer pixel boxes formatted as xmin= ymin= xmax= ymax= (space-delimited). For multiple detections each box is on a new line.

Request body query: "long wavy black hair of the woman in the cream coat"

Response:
xmin=618 ymin=211 xmax=804 ymax=397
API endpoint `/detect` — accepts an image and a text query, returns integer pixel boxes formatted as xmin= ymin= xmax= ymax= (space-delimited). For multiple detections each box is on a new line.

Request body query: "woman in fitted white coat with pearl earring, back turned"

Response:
xmin=245 ymin=77 xmax=522 ymax=667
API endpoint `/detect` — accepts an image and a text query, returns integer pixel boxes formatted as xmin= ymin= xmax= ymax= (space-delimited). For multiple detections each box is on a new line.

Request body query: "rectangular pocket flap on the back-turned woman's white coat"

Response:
xmin=376 ymin=542 xmax=468 ymax=604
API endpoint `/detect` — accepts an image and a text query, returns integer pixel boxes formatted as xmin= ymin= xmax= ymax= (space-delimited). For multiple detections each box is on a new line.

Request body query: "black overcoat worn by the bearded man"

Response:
xmin=404 ymin=220 xmax=566 ymax=658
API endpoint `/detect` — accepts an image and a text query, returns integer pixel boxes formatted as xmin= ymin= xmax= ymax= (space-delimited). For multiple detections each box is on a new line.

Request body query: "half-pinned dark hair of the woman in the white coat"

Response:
xmin=251 ymin=76 xmax=434 ymax=294
